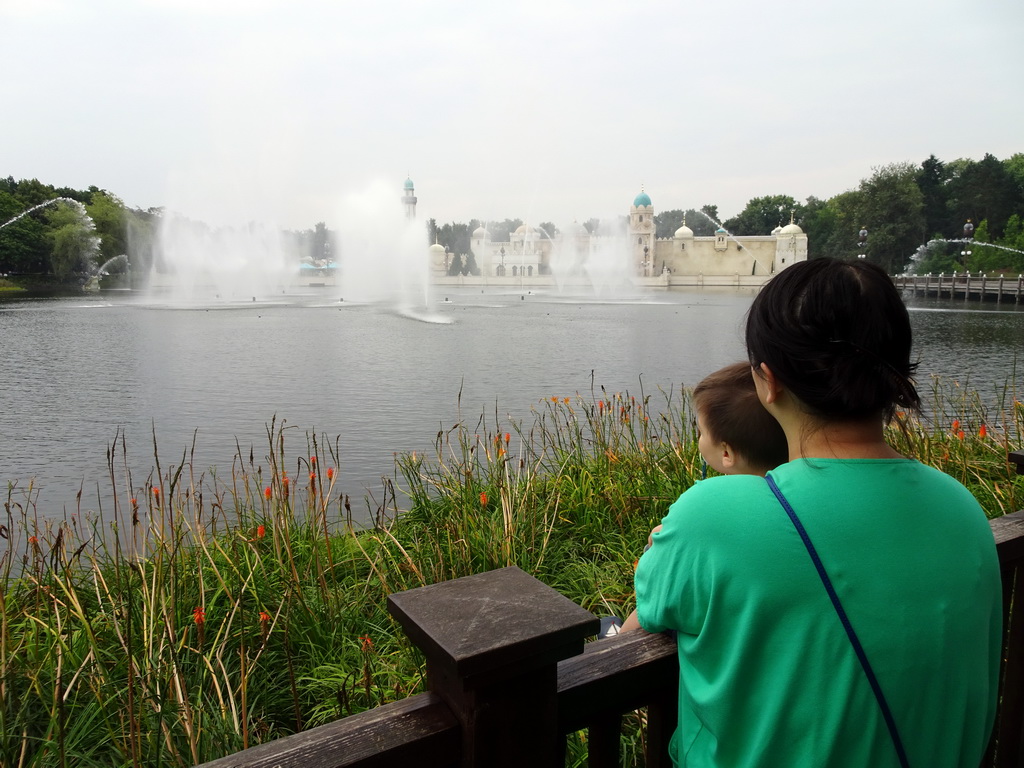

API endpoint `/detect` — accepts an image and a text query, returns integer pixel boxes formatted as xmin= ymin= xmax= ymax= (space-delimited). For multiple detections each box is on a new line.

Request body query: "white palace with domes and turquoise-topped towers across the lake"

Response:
xmin=402 ymin=179 xmax=807 ymax=288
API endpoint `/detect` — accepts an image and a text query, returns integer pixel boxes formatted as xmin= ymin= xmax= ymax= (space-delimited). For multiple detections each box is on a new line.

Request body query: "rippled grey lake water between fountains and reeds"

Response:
xmin=0 ymin=282 xmax=1024 ymax=514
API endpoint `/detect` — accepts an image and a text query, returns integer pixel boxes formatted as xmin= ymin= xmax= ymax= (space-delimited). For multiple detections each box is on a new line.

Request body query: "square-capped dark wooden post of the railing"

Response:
xmin=388 ymin=566 xmax=600 ymax=768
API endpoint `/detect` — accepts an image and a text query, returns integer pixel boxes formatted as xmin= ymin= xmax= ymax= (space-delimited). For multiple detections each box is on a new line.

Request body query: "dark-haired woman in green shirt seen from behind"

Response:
xmin=625 ymin=259 xmax=1000 ymax=768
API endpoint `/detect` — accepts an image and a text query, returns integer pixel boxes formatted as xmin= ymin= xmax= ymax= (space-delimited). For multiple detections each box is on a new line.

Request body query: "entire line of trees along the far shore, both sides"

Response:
xmin=0 ymin=153 xmax=1024 ymax=282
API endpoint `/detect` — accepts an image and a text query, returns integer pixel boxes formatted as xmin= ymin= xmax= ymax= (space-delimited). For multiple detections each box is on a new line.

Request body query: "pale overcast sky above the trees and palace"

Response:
xmin=0 ymin=0 xmax=1024 ymax=229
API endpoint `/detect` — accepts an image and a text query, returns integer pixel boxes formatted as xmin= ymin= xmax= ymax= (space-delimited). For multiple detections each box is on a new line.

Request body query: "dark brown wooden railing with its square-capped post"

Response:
xmin=199 ymin=452 xmax=1024 ymax=768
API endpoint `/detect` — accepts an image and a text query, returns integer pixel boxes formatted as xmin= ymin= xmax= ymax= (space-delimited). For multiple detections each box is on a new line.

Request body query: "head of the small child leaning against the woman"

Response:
xmin=693 ymin=362 xmax=790 ymax=475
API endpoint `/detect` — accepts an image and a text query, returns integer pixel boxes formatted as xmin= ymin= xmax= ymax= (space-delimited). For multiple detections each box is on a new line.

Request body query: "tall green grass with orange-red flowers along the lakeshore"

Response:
xmin=0 ymin=383 xmax=1024 ymax=767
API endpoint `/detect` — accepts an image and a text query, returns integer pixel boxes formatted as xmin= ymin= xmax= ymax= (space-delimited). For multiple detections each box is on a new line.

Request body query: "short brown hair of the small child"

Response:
xmin=693 ymin=362 xmax=790 ymax=472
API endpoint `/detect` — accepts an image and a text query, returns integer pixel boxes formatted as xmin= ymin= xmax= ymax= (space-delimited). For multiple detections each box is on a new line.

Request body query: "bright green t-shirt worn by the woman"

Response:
xmin=636 ymin=459 xmax=1001 ymax=768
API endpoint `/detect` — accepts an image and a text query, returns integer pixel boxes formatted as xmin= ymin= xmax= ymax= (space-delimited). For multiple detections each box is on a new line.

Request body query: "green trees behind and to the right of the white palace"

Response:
xmin=430 ymin=153 xmax=1024 ymax=274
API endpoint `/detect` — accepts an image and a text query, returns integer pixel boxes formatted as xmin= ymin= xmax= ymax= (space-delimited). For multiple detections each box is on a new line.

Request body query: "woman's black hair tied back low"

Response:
xmin=746 ymin=259 xmax=921 ymax=420
